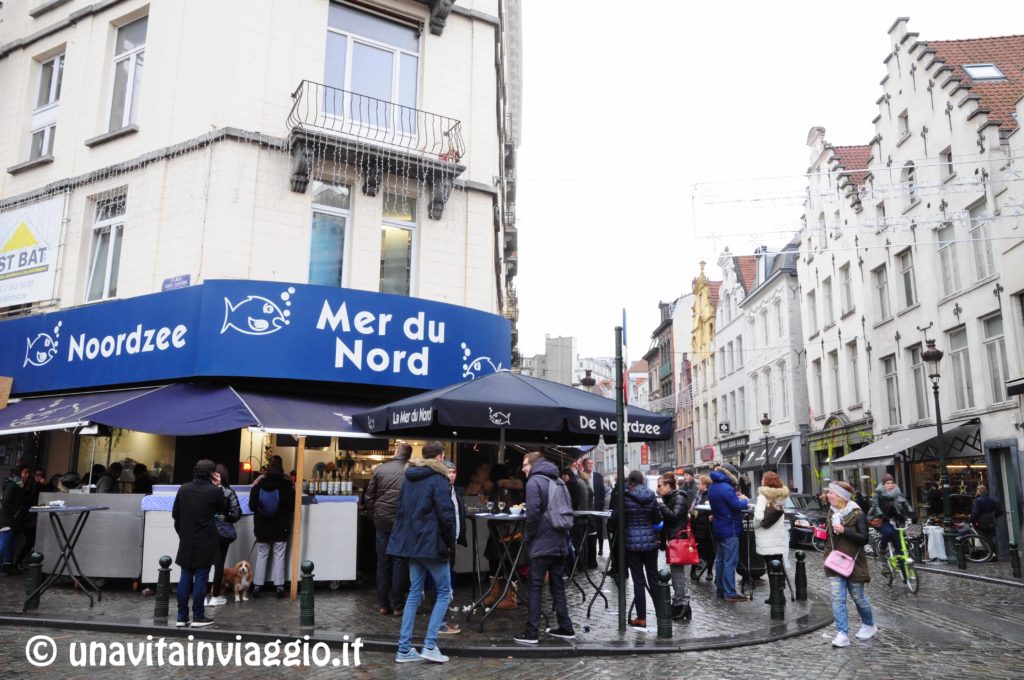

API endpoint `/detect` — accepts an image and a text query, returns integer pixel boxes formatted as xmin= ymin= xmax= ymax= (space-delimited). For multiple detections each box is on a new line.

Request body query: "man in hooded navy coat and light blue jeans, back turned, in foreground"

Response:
xmin=387 ymin=441 xmax=456 ymax=664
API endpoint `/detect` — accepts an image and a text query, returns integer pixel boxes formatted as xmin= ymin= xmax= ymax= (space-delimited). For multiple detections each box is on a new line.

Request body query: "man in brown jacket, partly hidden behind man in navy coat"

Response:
xmin=362 ymin=442 xmax=413 ymax=614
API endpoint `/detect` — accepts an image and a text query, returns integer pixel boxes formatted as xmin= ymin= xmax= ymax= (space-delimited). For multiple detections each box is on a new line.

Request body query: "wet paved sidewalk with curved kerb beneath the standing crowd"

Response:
xmin=0 ymin=564 xmax=833 ymax=658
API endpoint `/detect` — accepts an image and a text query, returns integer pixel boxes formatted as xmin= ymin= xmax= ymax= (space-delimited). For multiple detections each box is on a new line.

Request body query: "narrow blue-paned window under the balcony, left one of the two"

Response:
xmin=309 ymin=181 xmax=351 ymax=287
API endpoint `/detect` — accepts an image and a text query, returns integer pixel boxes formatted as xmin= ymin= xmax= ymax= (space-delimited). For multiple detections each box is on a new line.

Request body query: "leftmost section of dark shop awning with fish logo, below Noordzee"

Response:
xmin=0 ymin=387 xmax=158 ymax=435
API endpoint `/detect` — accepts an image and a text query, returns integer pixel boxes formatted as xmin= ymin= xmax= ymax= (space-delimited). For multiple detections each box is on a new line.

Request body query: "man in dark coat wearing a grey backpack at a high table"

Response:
xmin=513 ymin=451 xmax=575 ymax=644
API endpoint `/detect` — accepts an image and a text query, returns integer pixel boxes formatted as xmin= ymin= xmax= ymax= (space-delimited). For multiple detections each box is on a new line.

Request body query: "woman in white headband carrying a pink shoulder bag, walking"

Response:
xmin=824 ymin=481 xmax=879 ymax=647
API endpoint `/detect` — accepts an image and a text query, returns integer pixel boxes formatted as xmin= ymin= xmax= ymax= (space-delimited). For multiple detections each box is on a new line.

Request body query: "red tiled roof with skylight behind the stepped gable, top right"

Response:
xmin=913 ymin=36 xmax=1024 ymax=131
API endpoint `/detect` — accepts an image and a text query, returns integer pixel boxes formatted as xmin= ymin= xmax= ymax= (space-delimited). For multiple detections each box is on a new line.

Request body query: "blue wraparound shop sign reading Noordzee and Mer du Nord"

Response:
xmin=0 ymin=281 xmax=511 ymax=394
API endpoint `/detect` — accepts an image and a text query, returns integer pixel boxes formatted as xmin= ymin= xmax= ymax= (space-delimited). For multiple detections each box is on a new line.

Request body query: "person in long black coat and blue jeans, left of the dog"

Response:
xmin=171 ymin=459 xmax=227 ymax=628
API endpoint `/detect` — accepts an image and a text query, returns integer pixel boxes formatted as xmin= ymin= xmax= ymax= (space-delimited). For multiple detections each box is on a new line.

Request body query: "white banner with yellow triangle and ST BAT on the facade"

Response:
xmin=0 ymin=196 xmax=65 ymax=307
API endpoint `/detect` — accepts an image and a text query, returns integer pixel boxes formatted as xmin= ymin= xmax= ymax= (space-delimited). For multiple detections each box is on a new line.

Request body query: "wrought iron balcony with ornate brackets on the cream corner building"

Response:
xmin=288 ymin=80 xmax=466 ymax=219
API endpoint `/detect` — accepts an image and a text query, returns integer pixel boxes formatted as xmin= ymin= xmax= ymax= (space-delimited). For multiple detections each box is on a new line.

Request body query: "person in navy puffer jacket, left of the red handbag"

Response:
xmin=611 ymin=470 xmax=662 ymax=628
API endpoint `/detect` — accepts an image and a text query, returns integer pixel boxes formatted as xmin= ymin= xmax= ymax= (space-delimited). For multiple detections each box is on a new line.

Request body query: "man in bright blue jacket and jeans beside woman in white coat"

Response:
xmin=708 ymin=463 xmax=748 ymax=602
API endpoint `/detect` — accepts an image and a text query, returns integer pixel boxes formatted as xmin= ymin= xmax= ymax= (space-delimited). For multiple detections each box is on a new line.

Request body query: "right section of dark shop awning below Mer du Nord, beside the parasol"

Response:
xmin=236 ymin=389 xmax=374 ymax=440
